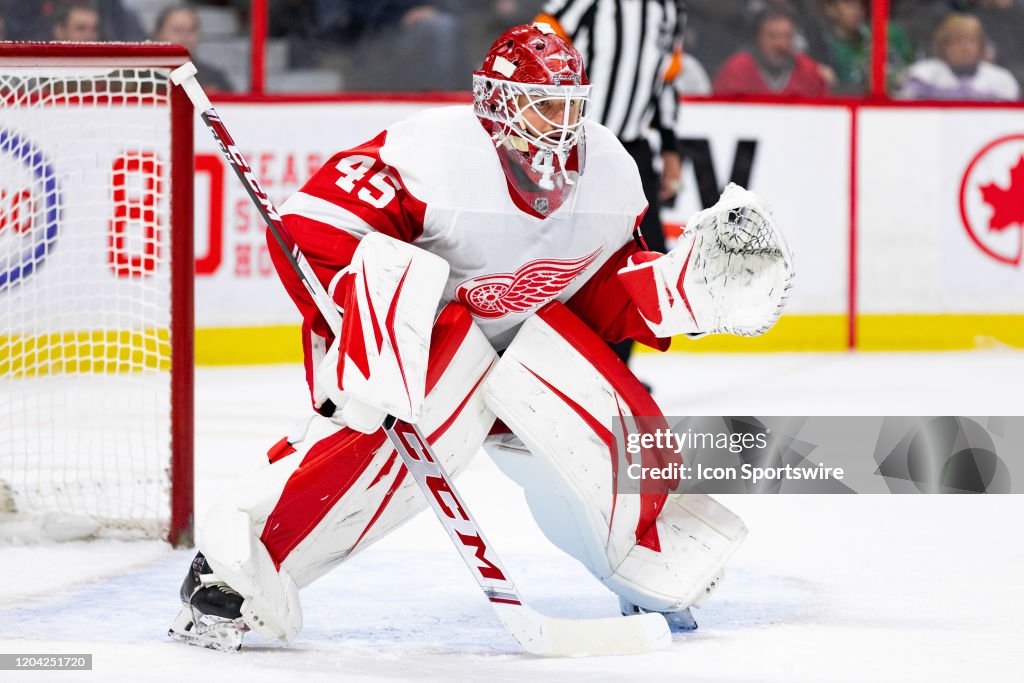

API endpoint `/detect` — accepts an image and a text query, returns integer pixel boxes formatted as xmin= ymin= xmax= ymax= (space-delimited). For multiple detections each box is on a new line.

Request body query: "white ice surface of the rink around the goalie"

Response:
xmin=0 ymin=351 xmax=1024 ymax=683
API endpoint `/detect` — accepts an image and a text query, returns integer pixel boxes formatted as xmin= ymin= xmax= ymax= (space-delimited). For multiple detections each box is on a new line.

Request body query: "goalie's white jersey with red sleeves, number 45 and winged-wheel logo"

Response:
xmin=271 ymin=105 xmax=658 ymax=401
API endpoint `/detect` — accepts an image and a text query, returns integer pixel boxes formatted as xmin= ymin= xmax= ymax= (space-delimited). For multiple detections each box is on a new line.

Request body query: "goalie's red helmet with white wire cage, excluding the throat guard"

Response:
xmin=473 ymin=24 xmax=590 ymax=157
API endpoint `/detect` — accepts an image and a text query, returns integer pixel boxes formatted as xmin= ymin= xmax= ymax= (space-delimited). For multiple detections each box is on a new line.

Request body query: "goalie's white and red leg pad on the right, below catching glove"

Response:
xmin=484 ymin=304 xmax=746 ymax=611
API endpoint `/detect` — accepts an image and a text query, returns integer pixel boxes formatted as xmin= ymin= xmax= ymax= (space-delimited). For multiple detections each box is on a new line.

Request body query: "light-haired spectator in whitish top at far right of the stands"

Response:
xmin=900 ymin=12 xmax=1020 ymax=100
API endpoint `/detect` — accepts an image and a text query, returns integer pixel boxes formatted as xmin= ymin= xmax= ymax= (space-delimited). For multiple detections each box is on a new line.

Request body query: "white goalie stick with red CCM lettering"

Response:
xmin=171 ymin=62 xmax=672 ymax=656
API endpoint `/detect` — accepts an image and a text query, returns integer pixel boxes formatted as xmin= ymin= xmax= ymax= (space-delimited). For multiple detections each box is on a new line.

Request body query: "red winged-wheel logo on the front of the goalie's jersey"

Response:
xmin=455 ymin=247 xmax=601 ymax=318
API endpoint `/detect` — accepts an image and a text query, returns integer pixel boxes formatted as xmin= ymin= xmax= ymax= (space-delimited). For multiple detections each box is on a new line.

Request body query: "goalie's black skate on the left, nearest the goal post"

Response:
xmin=167 ymin=553 xmax=249 ymax=650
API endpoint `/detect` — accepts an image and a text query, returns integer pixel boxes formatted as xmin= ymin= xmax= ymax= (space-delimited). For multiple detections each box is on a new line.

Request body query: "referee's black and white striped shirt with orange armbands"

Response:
xmin=538 ymin=0 xmax=686 ymax=150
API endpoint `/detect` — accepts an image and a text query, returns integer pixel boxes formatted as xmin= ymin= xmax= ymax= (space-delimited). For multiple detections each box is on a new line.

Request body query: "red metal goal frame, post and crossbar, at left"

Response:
xmin=0 ymin=42 xmax=195 ymax=547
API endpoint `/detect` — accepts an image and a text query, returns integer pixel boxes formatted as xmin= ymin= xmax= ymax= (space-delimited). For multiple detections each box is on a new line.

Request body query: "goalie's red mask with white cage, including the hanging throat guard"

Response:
xmin=473 ymin=24 xmax=590 ymax=214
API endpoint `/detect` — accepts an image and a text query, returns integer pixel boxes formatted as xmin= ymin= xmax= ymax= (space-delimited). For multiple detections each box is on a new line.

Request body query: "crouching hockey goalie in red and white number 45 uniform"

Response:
xmin=170 ymin=24 xmax=793 ymax=649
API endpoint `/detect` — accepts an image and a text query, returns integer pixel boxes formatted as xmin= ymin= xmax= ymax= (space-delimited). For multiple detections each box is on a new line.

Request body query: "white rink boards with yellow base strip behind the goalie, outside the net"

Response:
xmin=184 ymin=98 xmax=1024 ymax=365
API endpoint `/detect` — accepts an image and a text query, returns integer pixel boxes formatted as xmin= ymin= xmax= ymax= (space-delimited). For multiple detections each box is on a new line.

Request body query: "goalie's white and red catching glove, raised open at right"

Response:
xmin=618 ymin=183 xmax=794 ymax=337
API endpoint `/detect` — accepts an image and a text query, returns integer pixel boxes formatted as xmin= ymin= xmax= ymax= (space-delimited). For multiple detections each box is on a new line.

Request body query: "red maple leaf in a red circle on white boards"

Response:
xmin=959 ymin=134 xmax=1024 ymax=266
